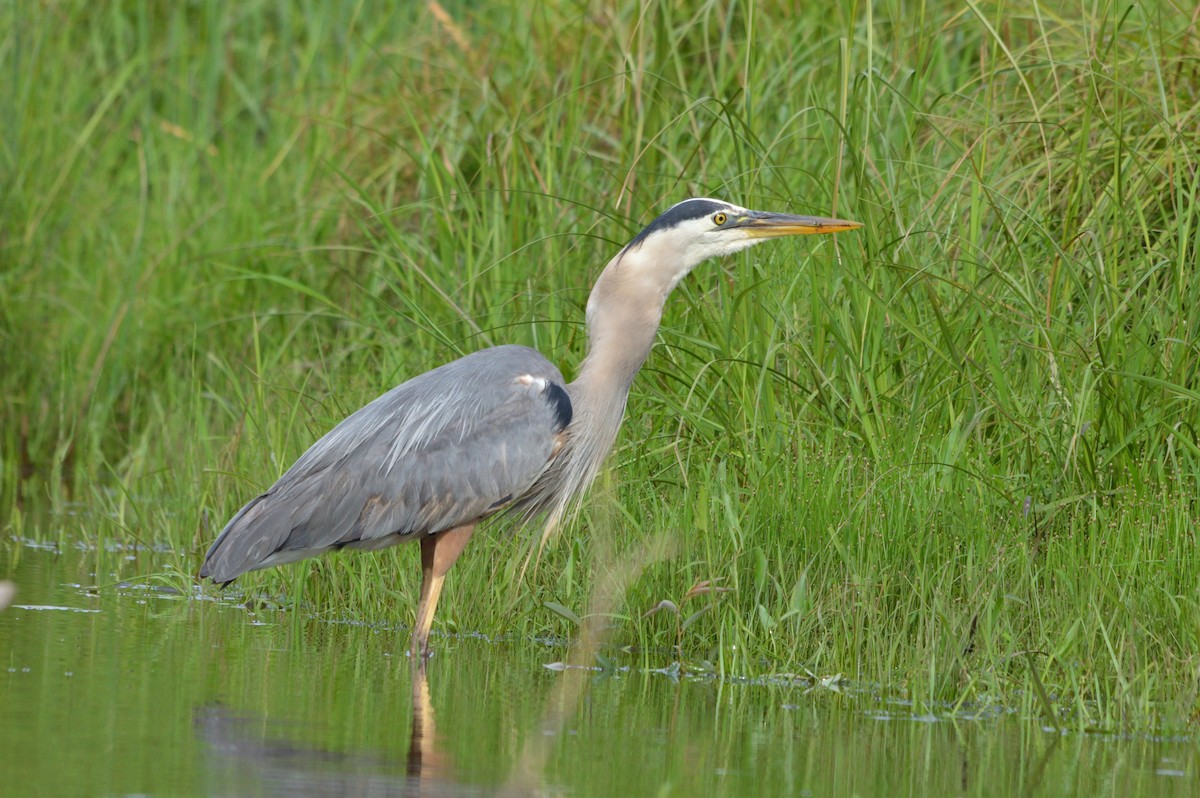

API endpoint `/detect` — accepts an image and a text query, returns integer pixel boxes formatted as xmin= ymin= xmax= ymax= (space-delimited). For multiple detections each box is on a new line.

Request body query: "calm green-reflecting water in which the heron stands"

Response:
xmin=0 ymin=541 xmax=1200 ymax=797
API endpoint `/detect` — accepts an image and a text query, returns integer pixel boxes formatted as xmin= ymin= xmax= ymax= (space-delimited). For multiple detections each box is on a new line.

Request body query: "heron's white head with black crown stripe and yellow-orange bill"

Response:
xmin=618 ymin=197 xmax=862 ymax=292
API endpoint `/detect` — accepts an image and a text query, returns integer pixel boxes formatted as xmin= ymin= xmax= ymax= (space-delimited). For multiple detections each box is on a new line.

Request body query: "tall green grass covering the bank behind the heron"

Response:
xmin=0 ymin=0 xmax=1200 ymax=730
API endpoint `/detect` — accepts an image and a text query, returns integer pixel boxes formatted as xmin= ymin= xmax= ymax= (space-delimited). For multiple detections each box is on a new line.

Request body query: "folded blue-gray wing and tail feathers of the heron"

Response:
xmin=200 ymin=346 xmax=571 ymax=582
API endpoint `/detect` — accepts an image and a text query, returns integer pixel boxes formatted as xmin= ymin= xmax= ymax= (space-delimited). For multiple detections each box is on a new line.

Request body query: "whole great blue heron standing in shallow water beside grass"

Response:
xmin=200 ymin=198 xmax=862 ymax=660
